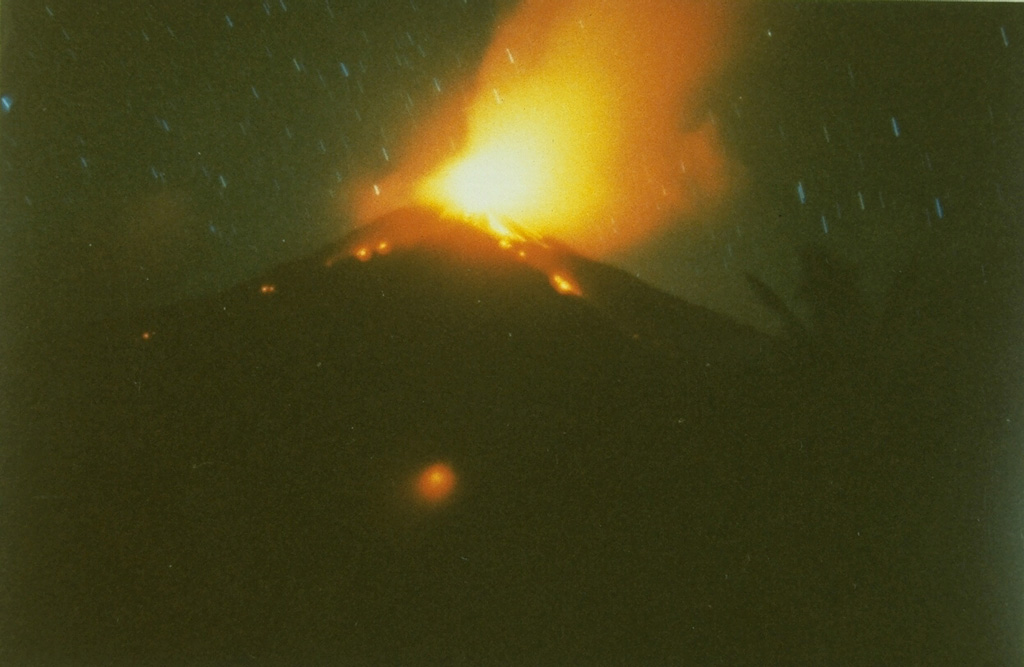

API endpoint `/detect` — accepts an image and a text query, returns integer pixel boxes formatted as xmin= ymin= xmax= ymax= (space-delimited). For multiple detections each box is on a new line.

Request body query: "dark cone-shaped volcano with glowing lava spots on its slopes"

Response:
xmin=2 ymin=209 xmax=1007 ymax=664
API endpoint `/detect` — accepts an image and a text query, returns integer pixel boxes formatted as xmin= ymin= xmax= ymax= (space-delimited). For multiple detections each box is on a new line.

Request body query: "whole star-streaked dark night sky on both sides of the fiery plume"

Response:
xmin=0 ymin=0 xmax=1024 ymax=340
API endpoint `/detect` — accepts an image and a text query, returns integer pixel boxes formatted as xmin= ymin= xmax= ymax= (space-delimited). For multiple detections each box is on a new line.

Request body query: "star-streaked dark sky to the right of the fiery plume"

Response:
xmin=631 ymin=3 xmax=1024 ymax=334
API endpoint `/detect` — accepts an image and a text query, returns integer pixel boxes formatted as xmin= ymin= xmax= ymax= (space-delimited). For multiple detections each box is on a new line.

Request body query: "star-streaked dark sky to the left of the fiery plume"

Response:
xmin=3 ymin=2 xmax=507 ymax=327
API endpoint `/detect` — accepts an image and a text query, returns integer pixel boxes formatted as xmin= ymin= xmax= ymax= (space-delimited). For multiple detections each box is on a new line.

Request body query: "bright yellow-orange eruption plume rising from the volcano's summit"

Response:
xmin=356 ymin=0 xmax=736 ymax=255
